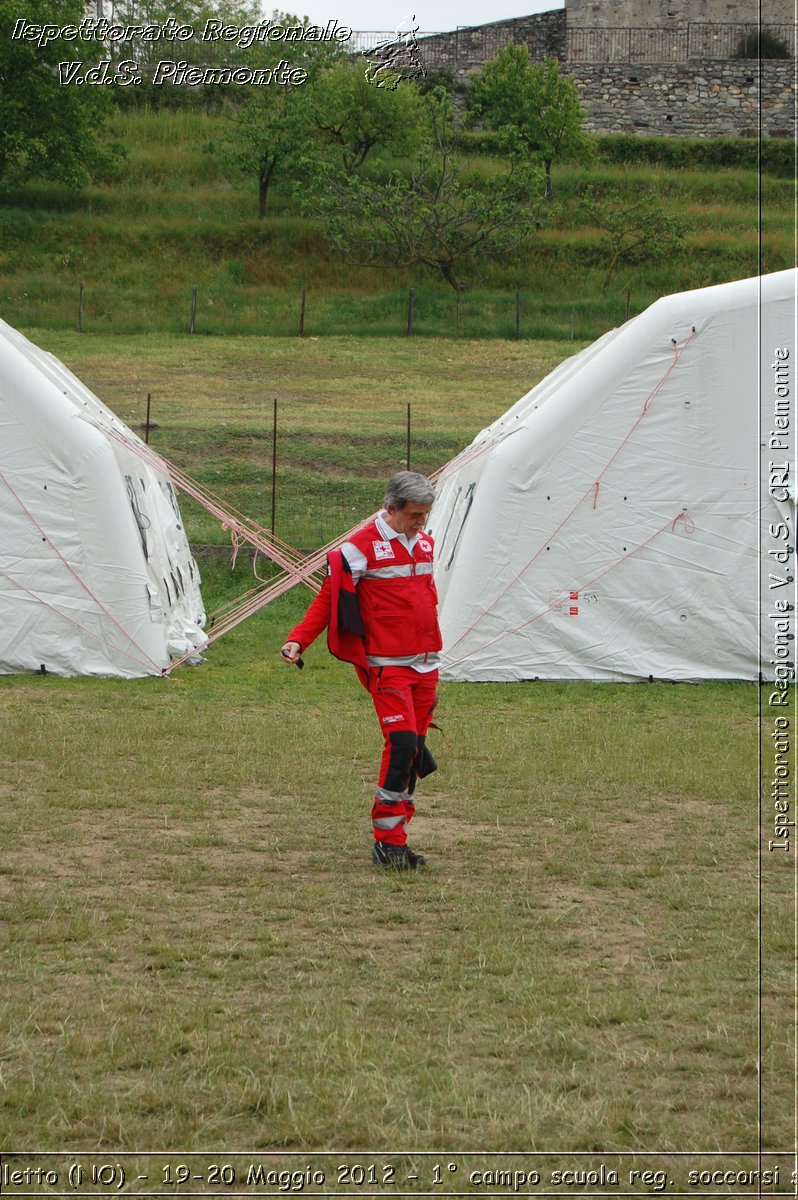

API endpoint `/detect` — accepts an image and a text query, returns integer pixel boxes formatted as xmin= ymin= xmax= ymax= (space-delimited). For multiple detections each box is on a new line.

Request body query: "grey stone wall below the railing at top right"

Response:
xmin=564 ymin=59 xmax=796 ymax=138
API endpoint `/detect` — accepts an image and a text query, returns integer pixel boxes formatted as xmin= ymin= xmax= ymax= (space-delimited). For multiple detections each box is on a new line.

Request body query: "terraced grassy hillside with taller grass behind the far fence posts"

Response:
xmin=0 ymin=110 xmax=782 ymax=338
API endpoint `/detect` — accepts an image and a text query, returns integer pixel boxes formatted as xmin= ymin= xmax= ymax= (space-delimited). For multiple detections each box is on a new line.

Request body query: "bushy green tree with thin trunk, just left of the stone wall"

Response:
xmin=469 ymin=46 xmax=593 ymax=199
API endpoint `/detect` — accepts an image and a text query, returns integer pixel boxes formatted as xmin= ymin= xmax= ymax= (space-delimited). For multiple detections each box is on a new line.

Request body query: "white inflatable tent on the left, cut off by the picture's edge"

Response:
xmin=0 ymin=322 xmax=205 ymax=678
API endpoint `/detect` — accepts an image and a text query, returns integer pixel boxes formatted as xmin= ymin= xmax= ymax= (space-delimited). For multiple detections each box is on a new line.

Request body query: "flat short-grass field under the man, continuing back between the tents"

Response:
xmin=0 ymin=331 xmax=794 ymax=1171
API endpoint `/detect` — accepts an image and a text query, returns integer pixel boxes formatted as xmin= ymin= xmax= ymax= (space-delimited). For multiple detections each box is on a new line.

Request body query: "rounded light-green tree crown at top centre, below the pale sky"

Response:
xmin=313 ymin=61 xmax=421 ymax=175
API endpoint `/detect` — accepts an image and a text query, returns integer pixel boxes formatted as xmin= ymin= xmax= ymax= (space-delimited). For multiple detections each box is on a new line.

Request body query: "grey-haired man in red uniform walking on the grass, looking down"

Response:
xmin=281 ymin=470 xmax=443 ymax=871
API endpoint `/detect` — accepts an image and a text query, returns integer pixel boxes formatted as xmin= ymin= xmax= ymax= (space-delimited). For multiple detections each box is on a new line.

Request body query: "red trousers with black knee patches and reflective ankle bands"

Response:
xmin=358 ymin=667 xmax=438 ymax=846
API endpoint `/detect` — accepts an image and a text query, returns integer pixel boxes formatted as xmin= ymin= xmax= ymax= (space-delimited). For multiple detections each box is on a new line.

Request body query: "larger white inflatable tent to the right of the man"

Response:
xmin=428 ymin=270 xmax=798 ymax=682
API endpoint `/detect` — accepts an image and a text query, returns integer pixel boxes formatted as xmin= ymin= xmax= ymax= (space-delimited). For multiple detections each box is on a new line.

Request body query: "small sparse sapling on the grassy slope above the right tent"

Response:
xmin=581 ymin=191 xmax=689 ymax=292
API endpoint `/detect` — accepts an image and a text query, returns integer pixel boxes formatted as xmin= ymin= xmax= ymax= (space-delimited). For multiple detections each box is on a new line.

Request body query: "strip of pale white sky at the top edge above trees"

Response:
xmin=292 ymin=0 xmax=564 ymax=37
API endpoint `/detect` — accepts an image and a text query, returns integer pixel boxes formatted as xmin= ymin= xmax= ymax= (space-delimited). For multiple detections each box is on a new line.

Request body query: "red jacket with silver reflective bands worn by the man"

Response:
xmin=286 ymin=522 xmax=443 ymax=667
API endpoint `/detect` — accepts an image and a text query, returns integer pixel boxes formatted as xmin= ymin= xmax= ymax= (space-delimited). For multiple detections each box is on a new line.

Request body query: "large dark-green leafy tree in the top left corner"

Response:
xmin=0 ymin=0 xmax=115 ymax=187
